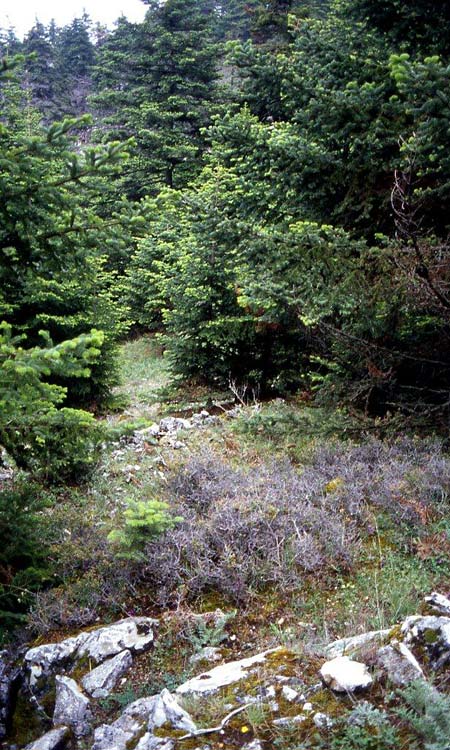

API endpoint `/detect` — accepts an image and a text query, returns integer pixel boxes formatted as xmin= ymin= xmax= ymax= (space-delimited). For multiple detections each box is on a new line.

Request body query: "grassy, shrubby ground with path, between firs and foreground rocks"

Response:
xmin=10 ymin=337 xmax=450 ymax=748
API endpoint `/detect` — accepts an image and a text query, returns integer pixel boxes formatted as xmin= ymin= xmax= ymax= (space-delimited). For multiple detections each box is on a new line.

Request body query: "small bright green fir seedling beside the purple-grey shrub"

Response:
xmin=108 ymin=500 xmax=183 ymax=562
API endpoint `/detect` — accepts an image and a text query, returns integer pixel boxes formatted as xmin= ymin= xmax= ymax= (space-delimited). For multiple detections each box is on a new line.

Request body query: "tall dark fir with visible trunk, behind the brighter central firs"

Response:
xmin=93 ymin=0 xmax=217 ymax=198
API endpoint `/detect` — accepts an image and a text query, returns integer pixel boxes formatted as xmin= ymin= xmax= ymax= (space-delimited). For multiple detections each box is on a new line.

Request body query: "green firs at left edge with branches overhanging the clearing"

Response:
xmin=0 ymin=60 xmax=137 ymax=481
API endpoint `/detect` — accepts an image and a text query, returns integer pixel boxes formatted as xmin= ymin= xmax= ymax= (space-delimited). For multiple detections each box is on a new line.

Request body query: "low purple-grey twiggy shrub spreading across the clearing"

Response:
xmin=142 ymin=439 xmax=450 ymax=604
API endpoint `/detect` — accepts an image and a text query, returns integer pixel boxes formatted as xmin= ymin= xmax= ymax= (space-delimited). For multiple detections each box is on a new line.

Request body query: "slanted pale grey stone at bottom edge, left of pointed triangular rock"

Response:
xmin=92 ymin=696 xmax=155 ymax=750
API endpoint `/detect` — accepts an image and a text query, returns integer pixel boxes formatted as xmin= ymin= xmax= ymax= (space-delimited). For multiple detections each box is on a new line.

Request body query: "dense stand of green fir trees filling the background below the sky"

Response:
xmin=0 ymin=0 xmax=450 ymax=636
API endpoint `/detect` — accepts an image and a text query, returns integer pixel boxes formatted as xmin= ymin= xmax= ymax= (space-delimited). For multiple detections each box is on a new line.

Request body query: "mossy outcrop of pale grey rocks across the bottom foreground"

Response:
xmin=0 ymin=593 xmax=450 ymax=750
